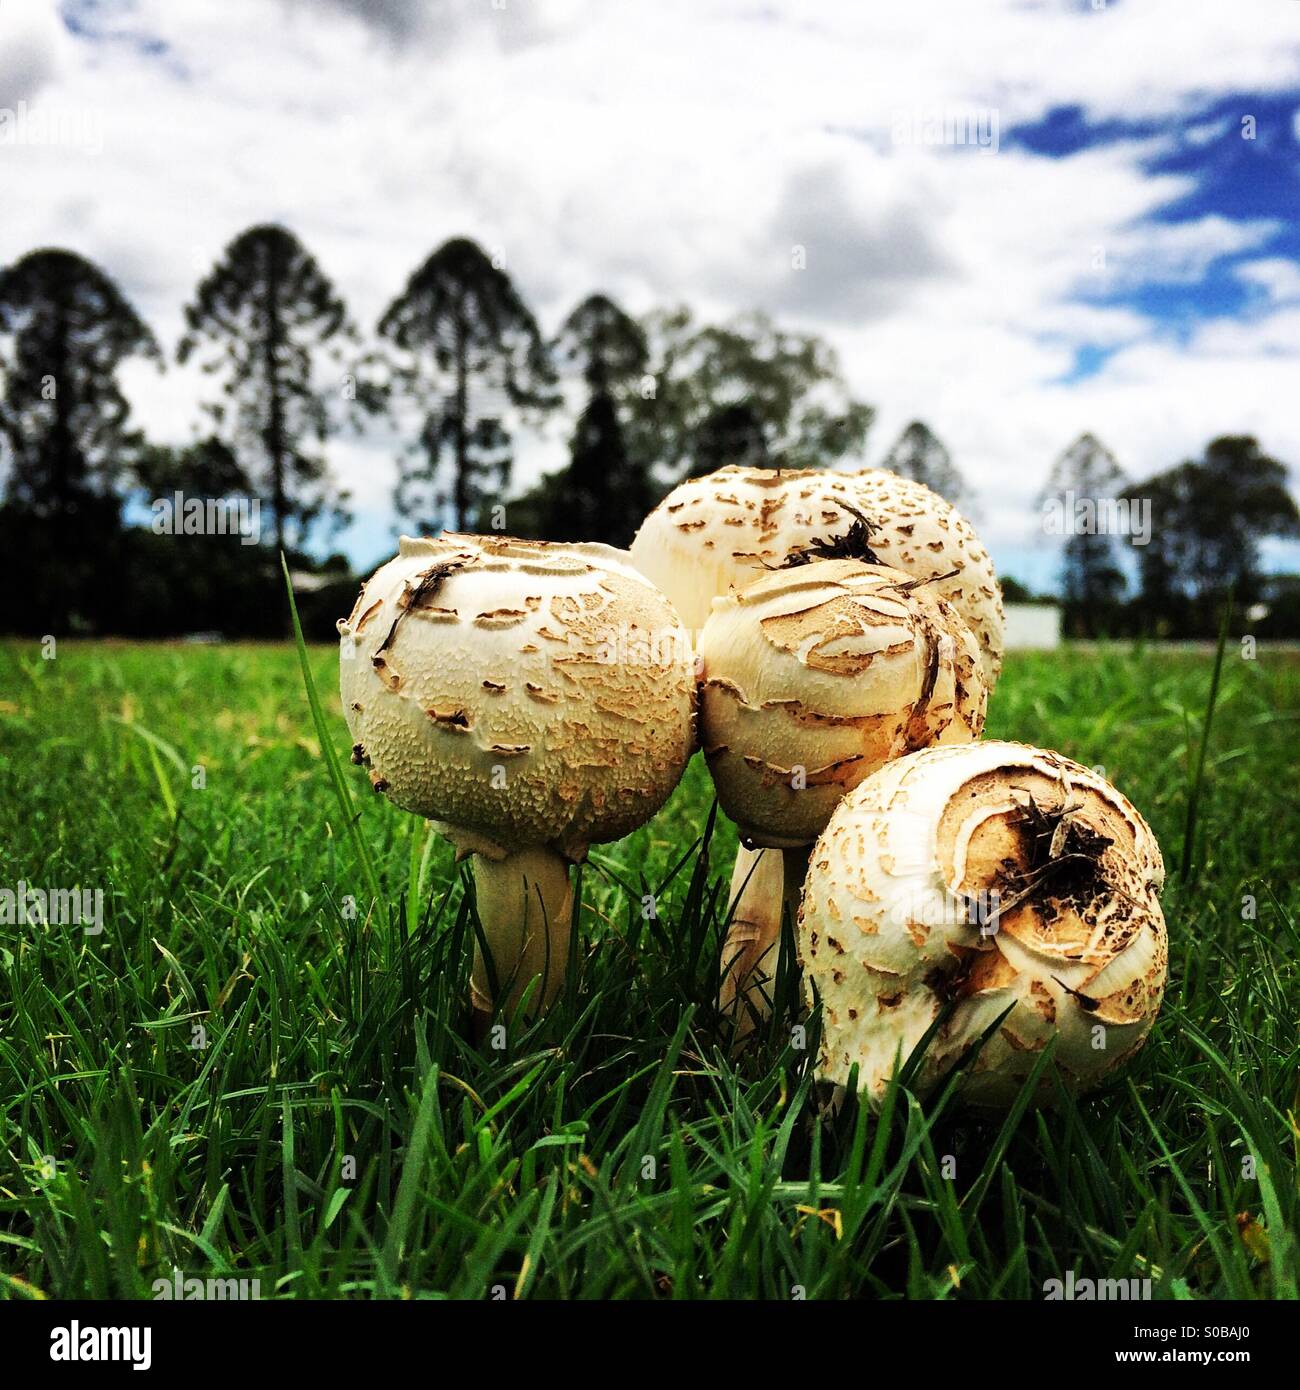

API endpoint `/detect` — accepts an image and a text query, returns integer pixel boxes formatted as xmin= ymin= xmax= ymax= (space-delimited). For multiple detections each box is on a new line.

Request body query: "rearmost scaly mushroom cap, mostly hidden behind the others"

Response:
xmin=631 ymin=466 xmax=1002 ymax=689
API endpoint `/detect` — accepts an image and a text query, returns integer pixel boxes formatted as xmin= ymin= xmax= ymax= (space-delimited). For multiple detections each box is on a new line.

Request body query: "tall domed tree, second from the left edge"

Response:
xmin=177 ymin=225 xmax=356 ymax=550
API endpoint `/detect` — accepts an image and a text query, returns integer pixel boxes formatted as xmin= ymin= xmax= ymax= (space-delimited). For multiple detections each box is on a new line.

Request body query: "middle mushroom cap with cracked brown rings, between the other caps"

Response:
xmin=698 ymin=560 xmax=987 ymax=848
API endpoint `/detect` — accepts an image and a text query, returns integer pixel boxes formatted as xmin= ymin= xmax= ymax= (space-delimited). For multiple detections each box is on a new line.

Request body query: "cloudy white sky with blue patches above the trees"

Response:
xmin=0 ymin=0 xmax=1300 ymax=588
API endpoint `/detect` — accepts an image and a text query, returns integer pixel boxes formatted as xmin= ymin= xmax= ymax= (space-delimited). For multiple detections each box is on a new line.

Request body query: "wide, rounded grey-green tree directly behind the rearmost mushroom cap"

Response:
xmin=628 ymin=309 xmax=875 ymax=484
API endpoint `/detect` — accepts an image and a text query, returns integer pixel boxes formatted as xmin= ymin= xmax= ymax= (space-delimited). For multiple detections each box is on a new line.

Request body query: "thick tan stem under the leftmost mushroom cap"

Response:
xmin=470 ymin=848 xmax=573 ymax=1019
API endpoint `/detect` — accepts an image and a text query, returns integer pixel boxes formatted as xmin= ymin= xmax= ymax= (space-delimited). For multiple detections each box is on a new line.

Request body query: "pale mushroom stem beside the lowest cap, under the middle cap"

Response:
xmin=717 ymin=845 xmax=809 ymax=1041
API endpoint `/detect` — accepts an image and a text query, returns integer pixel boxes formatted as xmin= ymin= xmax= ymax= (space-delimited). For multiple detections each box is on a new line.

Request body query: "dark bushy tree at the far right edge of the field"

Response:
xmin=1126 ymin=435 xmax=1300 ymax=634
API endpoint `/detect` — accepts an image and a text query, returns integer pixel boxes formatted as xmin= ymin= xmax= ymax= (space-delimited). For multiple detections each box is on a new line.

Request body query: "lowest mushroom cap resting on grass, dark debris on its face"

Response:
xmin=797 ymin=742 xmax=1168 ymax=1108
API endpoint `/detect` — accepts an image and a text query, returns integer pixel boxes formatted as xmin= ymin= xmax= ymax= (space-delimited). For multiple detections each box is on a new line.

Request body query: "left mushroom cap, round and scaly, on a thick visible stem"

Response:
xmin=338 ymin=535 xmax=694 ymax=859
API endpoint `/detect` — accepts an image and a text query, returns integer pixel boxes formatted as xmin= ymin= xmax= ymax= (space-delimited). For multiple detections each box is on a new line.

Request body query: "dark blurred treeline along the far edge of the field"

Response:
xmin=0 ymin=225 xmax=1300 ymax=637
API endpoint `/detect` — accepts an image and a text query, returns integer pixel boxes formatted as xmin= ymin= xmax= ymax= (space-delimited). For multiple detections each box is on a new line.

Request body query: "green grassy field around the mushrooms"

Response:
xmin=0 ymin=642 xmax=1300 ymax=1298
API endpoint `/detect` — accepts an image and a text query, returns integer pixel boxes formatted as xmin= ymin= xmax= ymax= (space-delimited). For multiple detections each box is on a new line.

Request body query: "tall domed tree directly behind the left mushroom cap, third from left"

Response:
xmin=380 ymin=238 xmax=555 ymax=530
